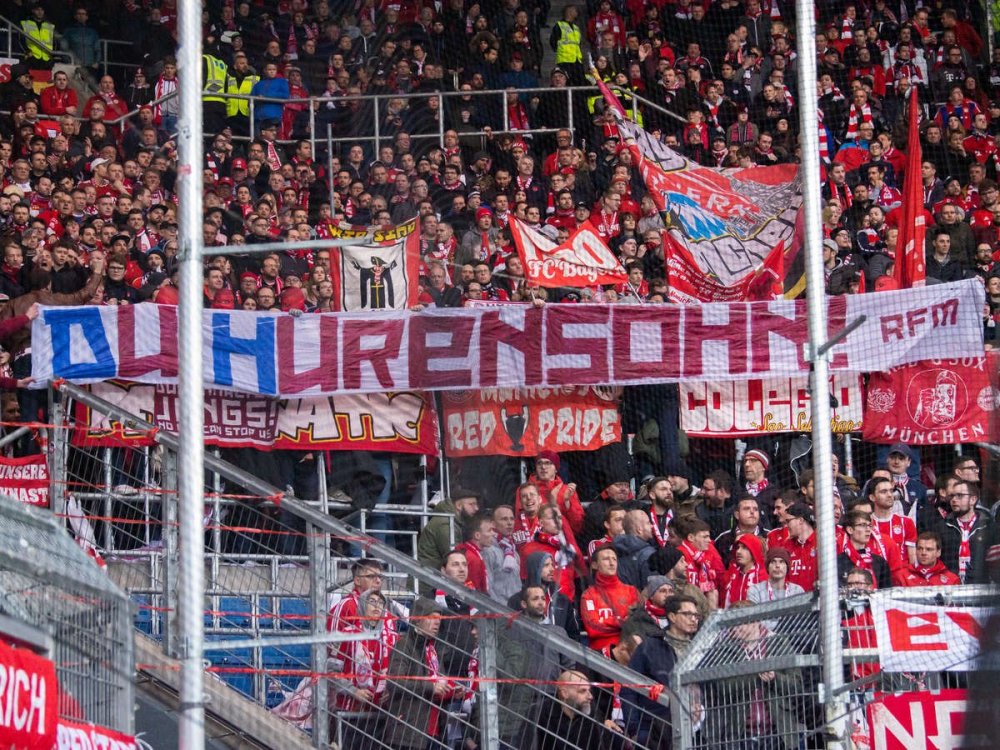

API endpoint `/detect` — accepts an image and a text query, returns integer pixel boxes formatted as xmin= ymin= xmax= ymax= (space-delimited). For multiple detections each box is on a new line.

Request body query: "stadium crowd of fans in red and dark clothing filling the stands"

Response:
xmin=0 ymin=0 xmax=1000 ymax=748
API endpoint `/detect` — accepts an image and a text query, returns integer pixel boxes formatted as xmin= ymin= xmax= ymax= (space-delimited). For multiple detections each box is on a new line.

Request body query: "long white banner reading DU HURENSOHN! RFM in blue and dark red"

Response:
xmin=31 ymin=279 xmax=983 ymax=397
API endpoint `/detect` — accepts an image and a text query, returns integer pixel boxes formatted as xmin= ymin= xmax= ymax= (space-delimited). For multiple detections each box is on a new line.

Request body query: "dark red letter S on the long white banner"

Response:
xmin=545 ymin=305 xmax=611 ymax=385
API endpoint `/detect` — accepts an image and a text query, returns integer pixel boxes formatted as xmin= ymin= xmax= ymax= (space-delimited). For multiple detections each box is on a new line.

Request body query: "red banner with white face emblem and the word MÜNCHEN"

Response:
xmin=864 ymin=354 xmax=1000 ymax=445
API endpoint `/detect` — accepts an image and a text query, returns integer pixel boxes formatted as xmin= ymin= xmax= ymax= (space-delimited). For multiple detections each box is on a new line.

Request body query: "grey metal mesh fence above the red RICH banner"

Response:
xmin=0 ymin=497 xmax=134 ymax=735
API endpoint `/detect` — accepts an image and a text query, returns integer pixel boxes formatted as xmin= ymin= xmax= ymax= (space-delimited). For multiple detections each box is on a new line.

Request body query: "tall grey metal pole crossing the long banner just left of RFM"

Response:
xmin=796 ymin=0 xmax=847 ymax=750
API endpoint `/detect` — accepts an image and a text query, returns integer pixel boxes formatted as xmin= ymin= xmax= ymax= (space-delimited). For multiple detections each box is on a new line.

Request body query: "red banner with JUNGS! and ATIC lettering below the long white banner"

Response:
xmin=74 ymin=381 xmax=438 ymax=455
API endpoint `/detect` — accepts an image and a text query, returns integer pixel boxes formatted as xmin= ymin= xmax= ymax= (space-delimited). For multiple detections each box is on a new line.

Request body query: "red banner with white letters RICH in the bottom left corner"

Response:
xmin=0 ymin=640 xmax=59 ymax=750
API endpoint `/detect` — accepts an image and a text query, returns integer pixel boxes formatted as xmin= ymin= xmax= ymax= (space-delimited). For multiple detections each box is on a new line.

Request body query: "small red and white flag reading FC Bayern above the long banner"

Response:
xmin=510 ymin=217 xmax=628 ymax=287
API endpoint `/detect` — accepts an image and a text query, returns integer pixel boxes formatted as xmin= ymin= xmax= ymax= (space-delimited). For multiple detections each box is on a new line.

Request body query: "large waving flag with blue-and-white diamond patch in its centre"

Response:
xmin=598 ymin=82 xmax=802 ymax=302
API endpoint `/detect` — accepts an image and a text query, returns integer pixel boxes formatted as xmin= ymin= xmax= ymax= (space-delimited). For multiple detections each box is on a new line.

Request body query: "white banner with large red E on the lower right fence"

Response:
xmin=871 ymin=596 xmax=990 ymax=672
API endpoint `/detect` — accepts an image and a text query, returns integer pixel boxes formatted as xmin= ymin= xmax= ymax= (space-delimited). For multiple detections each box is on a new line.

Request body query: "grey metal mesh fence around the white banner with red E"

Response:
xmin=672 ymin=586 xmax=1000 ymax=750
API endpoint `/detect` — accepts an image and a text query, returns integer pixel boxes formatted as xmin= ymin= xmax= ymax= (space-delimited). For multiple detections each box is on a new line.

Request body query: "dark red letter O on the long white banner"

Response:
xmin=611 ymin=307 xmax=681 ymax=383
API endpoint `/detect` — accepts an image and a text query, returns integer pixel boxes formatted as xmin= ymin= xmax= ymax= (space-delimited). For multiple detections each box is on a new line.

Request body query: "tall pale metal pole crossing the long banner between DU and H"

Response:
xmin=177 ymin=0 xmax=205 ymax=750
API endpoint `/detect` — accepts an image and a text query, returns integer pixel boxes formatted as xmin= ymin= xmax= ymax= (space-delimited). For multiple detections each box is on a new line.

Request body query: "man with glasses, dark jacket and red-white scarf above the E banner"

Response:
xmin=937 ymin=480 xmax=993 ymax=583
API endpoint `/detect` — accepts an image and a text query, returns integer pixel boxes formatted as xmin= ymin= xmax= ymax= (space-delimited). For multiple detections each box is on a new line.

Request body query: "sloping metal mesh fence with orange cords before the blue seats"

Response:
xmin=50 ymin=384 xmax=667 ymax=750
